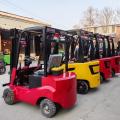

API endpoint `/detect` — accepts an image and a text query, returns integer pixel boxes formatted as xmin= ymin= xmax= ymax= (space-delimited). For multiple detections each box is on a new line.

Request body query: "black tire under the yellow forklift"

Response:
xmin=77 ymin=81 xmax=89 ymax=94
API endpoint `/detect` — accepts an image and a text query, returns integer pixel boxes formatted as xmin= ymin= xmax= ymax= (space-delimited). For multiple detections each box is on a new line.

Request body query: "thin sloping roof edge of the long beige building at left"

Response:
xmin=0 ymin=11 xmax=51 ymax=26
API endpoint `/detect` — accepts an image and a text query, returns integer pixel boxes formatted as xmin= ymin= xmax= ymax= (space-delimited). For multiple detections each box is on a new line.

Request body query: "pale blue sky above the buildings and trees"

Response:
xmin=0 ymin=0 xmax=120 ymax=29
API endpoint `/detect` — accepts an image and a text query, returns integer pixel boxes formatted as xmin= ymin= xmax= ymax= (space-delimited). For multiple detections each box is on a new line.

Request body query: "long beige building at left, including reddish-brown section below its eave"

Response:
xmin=0 ymin=11 xmax=51 ymax=51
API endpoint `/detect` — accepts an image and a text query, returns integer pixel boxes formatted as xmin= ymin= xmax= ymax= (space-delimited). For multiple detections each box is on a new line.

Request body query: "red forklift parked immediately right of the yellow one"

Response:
xmin=89 ymin=33 xmax=112 ymax=83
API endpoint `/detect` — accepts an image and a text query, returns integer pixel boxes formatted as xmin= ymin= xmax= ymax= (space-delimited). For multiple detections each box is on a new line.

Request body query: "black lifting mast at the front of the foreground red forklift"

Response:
xmin=10 ymin=29 xmax=31 ymax=71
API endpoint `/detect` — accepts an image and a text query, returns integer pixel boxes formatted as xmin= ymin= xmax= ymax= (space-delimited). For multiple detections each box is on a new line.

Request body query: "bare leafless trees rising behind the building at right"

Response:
xmin=73 ymin=7 xmax=116 ymax=29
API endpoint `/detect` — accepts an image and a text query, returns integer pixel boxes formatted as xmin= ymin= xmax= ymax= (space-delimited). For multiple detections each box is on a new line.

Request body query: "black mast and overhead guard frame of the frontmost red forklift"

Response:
xmin=10 ymin=27 xmax=69 ymax=76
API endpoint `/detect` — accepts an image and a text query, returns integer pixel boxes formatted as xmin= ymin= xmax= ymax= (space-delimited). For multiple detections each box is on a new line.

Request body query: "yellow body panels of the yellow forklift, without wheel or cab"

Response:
xmin=52 ymin=61 xmax=100 ymax=88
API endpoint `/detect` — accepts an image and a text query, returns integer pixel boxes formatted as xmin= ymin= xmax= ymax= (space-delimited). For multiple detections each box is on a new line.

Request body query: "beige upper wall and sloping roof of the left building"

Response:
xmin=0 ymin=11 xmax=51 ymax=29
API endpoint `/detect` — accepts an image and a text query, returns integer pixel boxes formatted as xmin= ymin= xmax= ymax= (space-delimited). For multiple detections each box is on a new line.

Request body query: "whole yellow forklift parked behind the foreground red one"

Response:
xmin=55 ymin=30 xmax=100 ymax=94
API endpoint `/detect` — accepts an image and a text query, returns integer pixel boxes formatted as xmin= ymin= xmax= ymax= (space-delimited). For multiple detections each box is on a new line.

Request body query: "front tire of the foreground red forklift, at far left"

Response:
xmin=3 ymin=88 xmax=15 ymax=105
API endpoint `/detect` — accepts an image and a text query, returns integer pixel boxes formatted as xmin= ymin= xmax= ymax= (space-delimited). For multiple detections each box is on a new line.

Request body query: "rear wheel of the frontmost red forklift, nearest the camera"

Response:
xmin=40 ymin=99 xmax=57 ymax=118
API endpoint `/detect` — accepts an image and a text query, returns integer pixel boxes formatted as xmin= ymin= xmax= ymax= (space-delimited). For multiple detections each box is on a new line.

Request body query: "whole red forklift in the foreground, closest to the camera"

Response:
xmin=3 ymin=26 xmax=76 ymax=118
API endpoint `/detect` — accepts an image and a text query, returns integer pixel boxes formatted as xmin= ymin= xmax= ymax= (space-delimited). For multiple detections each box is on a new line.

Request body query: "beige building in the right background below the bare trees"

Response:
xmin=83 ymin=24 xmax=120 ymax=43
